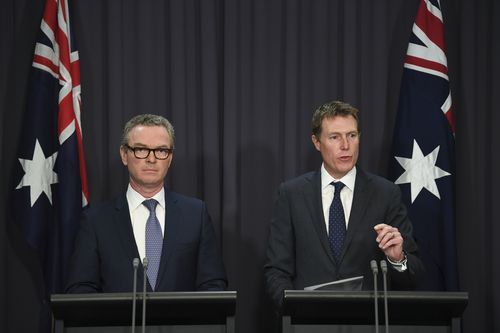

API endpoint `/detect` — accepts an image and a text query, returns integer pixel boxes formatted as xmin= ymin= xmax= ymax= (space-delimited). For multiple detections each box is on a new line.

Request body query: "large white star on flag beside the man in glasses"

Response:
xmin=16 ymin=139 xmax=57 ymax=207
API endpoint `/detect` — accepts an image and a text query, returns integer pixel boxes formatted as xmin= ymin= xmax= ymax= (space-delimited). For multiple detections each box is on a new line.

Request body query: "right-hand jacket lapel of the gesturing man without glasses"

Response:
xmin=342 ymin=168 xmax=375 ymax=257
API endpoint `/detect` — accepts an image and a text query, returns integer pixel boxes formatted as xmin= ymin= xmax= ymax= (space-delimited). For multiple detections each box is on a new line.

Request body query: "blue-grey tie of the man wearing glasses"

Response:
xmin=142 ymin=199 xmax=163 ymax=290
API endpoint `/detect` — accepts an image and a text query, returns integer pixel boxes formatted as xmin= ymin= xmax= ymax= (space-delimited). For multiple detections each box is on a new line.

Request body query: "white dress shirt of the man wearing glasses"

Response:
xmin=127 ymin=184 xmax=165 ymax=262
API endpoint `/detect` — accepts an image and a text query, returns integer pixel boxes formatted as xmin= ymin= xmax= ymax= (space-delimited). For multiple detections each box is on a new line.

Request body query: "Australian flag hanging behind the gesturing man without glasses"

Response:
xmin=390 ymin=0 xmax=458 ymax=290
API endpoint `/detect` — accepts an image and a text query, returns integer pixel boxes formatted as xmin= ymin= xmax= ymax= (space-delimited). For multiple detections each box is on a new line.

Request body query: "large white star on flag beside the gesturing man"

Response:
xmin=395 ymin=140 xmax=450 ymax=203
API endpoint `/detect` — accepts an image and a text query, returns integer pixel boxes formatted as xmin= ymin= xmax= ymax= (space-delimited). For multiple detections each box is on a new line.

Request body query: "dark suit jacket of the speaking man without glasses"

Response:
xmin=264 ymin=168 xmax=423 ymax=306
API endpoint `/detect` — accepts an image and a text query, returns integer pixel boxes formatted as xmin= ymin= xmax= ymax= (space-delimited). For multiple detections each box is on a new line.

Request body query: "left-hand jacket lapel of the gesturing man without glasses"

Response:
xmin=304 ymin=171 xmax=335 ymax=265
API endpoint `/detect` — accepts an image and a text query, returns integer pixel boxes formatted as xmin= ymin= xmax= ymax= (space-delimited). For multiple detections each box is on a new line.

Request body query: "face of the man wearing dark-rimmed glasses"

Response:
xmin=120 ymin=125 xmax=172 ymax=195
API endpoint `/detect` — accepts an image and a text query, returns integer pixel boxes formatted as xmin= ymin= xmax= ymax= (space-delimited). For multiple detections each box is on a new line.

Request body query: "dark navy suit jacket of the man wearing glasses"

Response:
xmin=66 ymin=189 xmax=227 ymax=293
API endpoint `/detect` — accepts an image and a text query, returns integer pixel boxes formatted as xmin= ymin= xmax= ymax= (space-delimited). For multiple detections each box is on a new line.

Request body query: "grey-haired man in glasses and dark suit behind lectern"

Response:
xmin=67 ymin=114 xmax=227 ymax=293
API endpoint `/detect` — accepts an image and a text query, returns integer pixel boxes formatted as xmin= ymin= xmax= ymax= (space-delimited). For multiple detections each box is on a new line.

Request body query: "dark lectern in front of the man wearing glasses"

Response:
xmin=51 ymin=291 xmax=236 ymax=333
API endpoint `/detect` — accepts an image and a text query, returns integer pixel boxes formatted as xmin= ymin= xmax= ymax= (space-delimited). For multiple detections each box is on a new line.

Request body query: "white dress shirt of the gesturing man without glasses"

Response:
xmin=321 ymin=163 xmax=356 ymax=232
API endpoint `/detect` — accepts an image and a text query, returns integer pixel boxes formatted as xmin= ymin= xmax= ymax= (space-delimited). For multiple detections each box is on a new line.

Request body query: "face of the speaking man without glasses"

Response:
xmin=312 ymin=116 xmax=359 ymax=179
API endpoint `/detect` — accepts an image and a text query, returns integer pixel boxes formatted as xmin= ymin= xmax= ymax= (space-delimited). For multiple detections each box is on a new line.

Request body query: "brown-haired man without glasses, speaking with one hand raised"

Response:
xmin=264 ymin=101 xmax=423 ymax=308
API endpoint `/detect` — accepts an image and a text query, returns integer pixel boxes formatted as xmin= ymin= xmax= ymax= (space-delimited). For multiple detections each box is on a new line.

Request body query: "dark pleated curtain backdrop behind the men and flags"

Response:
xmin=0 ymin=0 xmax=500 ymax=333
